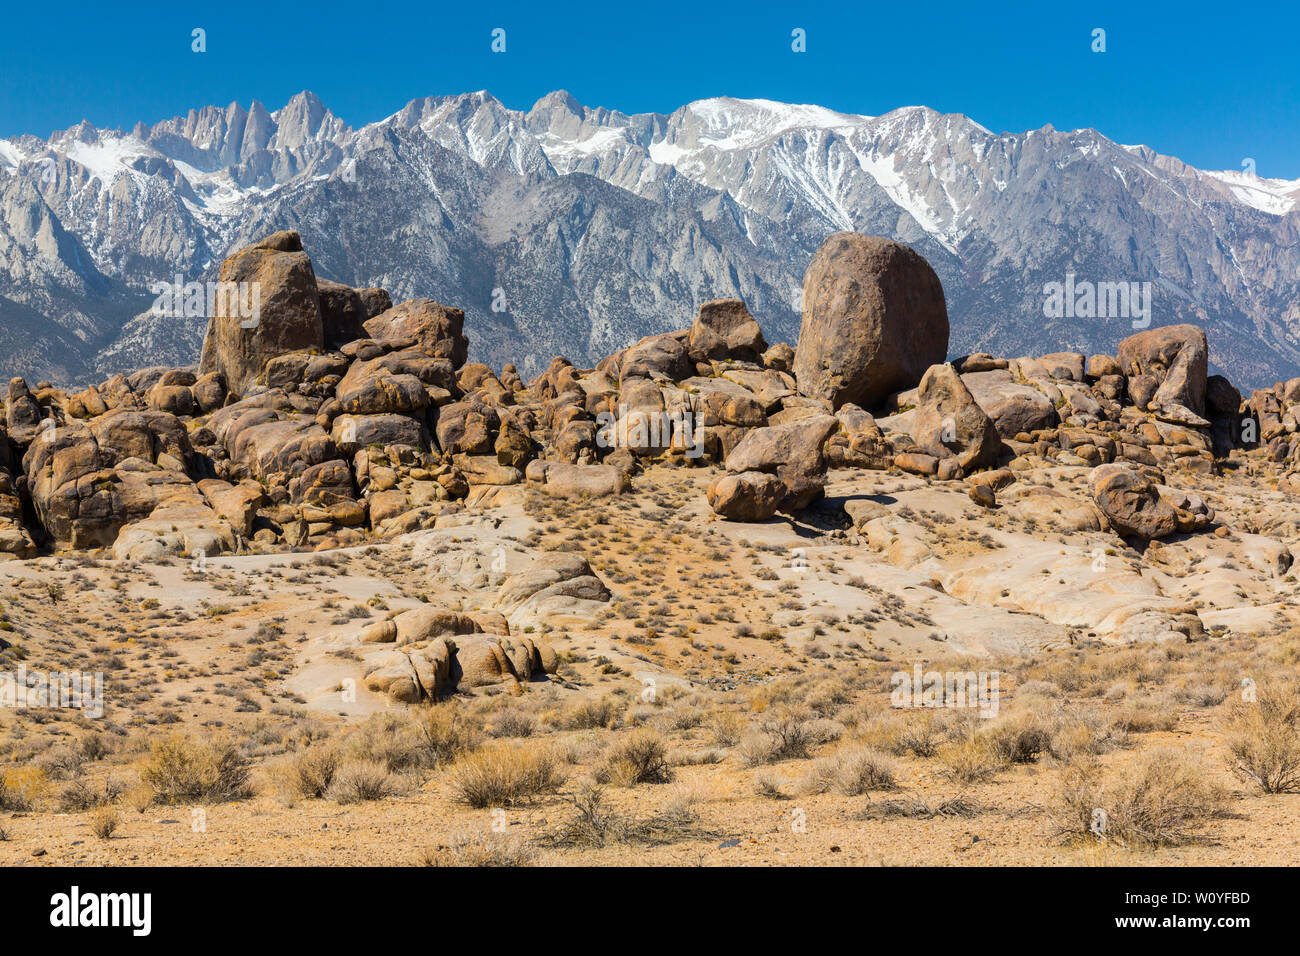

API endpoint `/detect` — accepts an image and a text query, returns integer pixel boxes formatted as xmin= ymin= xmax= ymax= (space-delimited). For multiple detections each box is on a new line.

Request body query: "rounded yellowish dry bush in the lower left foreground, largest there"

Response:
xmin=140 ymin=734 xmax=251 ymax=804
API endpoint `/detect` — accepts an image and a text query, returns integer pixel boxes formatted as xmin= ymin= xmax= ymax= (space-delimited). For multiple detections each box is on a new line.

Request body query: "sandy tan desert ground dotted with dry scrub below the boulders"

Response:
xmin=0 ymin=460 xmax=1300 ymax=866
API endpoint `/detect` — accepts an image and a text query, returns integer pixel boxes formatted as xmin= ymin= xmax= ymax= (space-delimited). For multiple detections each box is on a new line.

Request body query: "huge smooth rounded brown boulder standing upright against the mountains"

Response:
xmin=794 ymin=233 xmax=948 ymax=410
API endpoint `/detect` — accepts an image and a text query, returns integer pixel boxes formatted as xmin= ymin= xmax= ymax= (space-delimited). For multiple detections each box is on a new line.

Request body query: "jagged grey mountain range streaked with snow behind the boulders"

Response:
xmin=0 ymin=92 xmax=1300 ymax=386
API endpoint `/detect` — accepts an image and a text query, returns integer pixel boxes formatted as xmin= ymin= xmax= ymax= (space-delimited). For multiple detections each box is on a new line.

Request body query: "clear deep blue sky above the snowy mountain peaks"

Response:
xmin=0 ymin=0 xmax=1300 ymax=178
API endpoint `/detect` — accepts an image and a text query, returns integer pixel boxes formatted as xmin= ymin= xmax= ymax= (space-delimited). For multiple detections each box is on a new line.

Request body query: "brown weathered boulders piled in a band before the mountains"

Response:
xmin=0 ymin=232 xmax=1300 ymax=697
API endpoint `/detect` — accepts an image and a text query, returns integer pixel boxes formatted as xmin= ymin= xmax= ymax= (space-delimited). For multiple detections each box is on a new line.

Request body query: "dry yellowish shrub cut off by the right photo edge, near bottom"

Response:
xmin=1225 ymin=680 xmax=1300 ymax=793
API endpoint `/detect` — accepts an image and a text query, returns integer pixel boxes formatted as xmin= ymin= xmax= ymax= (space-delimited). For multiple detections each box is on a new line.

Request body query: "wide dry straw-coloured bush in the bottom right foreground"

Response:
xmin=1057 ymin=749 xmax=1227 ymax=847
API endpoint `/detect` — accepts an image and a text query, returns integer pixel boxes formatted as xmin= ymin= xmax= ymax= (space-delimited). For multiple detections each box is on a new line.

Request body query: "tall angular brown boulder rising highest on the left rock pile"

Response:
xmin=199 ymin=232 xmax=324 ymax=395
